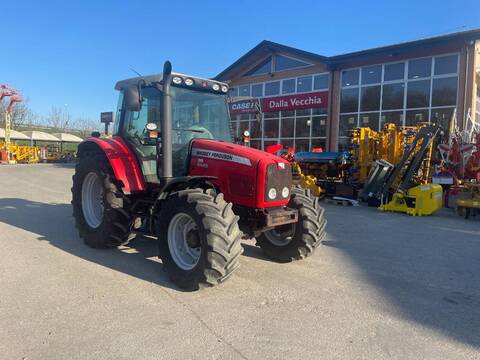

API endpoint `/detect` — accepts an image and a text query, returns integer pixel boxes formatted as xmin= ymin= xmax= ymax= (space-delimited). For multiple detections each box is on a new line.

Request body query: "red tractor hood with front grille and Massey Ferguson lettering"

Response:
xmin=189 ymin=139 xmax=292 ymax=209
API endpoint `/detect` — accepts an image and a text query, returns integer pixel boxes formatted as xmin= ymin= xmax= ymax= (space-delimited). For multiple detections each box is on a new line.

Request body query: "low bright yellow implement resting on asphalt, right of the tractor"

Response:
xmin=378 ymin=184 xmax=443 ymax=216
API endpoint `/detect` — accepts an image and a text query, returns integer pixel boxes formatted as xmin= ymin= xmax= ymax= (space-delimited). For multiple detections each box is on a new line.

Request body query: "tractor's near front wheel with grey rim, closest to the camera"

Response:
xmin=156 ymin=189 xmax=243 ymax=290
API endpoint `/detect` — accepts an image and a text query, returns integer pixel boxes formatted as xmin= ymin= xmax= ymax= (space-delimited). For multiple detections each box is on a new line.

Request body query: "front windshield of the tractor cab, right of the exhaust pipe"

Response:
xmin=171 ymin=87 xmax=232 ymax=144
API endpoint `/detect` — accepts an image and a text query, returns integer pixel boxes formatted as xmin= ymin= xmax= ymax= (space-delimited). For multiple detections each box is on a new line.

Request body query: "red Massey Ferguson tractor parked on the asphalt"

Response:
xmin=72 ymin=61 xmax=326 ymax=290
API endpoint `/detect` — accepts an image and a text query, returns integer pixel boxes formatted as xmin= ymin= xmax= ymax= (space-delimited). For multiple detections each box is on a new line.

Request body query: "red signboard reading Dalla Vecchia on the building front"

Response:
xmin=262 ymin=91 xmax=328 ymax=112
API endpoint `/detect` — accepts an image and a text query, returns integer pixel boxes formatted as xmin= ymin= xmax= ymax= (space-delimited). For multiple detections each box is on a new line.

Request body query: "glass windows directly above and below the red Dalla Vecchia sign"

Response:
xmin=230 ymin=73 xmax=329 ymax=151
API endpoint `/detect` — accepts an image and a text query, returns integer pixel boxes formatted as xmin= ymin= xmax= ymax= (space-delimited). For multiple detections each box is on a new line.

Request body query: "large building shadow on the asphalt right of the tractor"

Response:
xmin=323 ymin=207 xmax=480 ymax=347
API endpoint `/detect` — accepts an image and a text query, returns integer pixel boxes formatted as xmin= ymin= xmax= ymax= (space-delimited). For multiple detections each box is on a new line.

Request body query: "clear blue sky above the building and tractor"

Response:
xmin=0 ymin=0 xmax=480 ymax=118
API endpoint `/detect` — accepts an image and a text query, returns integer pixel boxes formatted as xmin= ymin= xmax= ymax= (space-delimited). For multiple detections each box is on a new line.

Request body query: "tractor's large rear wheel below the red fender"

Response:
xmin=72 ymin=152 xmax=135 ymax=248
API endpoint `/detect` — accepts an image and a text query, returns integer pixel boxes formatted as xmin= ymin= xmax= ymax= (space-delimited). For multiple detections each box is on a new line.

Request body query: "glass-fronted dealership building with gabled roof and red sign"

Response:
xmin=216 ymin=29 xmax=480 ymax=151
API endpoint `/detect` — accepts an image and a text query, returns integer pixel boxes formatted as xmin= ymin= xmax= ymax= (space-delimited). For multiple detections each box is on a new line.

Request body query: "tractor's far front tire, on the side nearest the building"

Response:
xmin=257 ymin=187 xmax=327 ymax=262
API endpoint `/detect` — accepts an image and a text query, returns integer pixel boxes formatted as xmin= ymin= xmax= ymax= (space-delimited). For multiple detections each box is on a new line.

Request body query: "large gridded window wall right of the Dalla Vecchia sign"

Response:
xmin=338 ymin=54 xmax=459 ymax=149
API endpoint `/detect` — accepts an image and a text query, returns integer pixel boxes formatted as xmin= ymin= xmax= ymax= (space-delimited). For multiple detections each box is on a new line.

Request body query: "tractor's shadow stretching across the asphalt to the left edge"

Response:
xmin=0 ymin=198 xmax=182 ymax=291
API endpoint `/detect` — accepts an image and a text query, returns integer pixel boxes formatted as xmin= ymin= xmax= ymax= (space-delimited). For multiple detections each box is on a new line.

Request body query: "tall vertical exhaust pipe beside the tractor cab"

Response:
xmin=161 ymin=61 xmax=173 ymax=179
